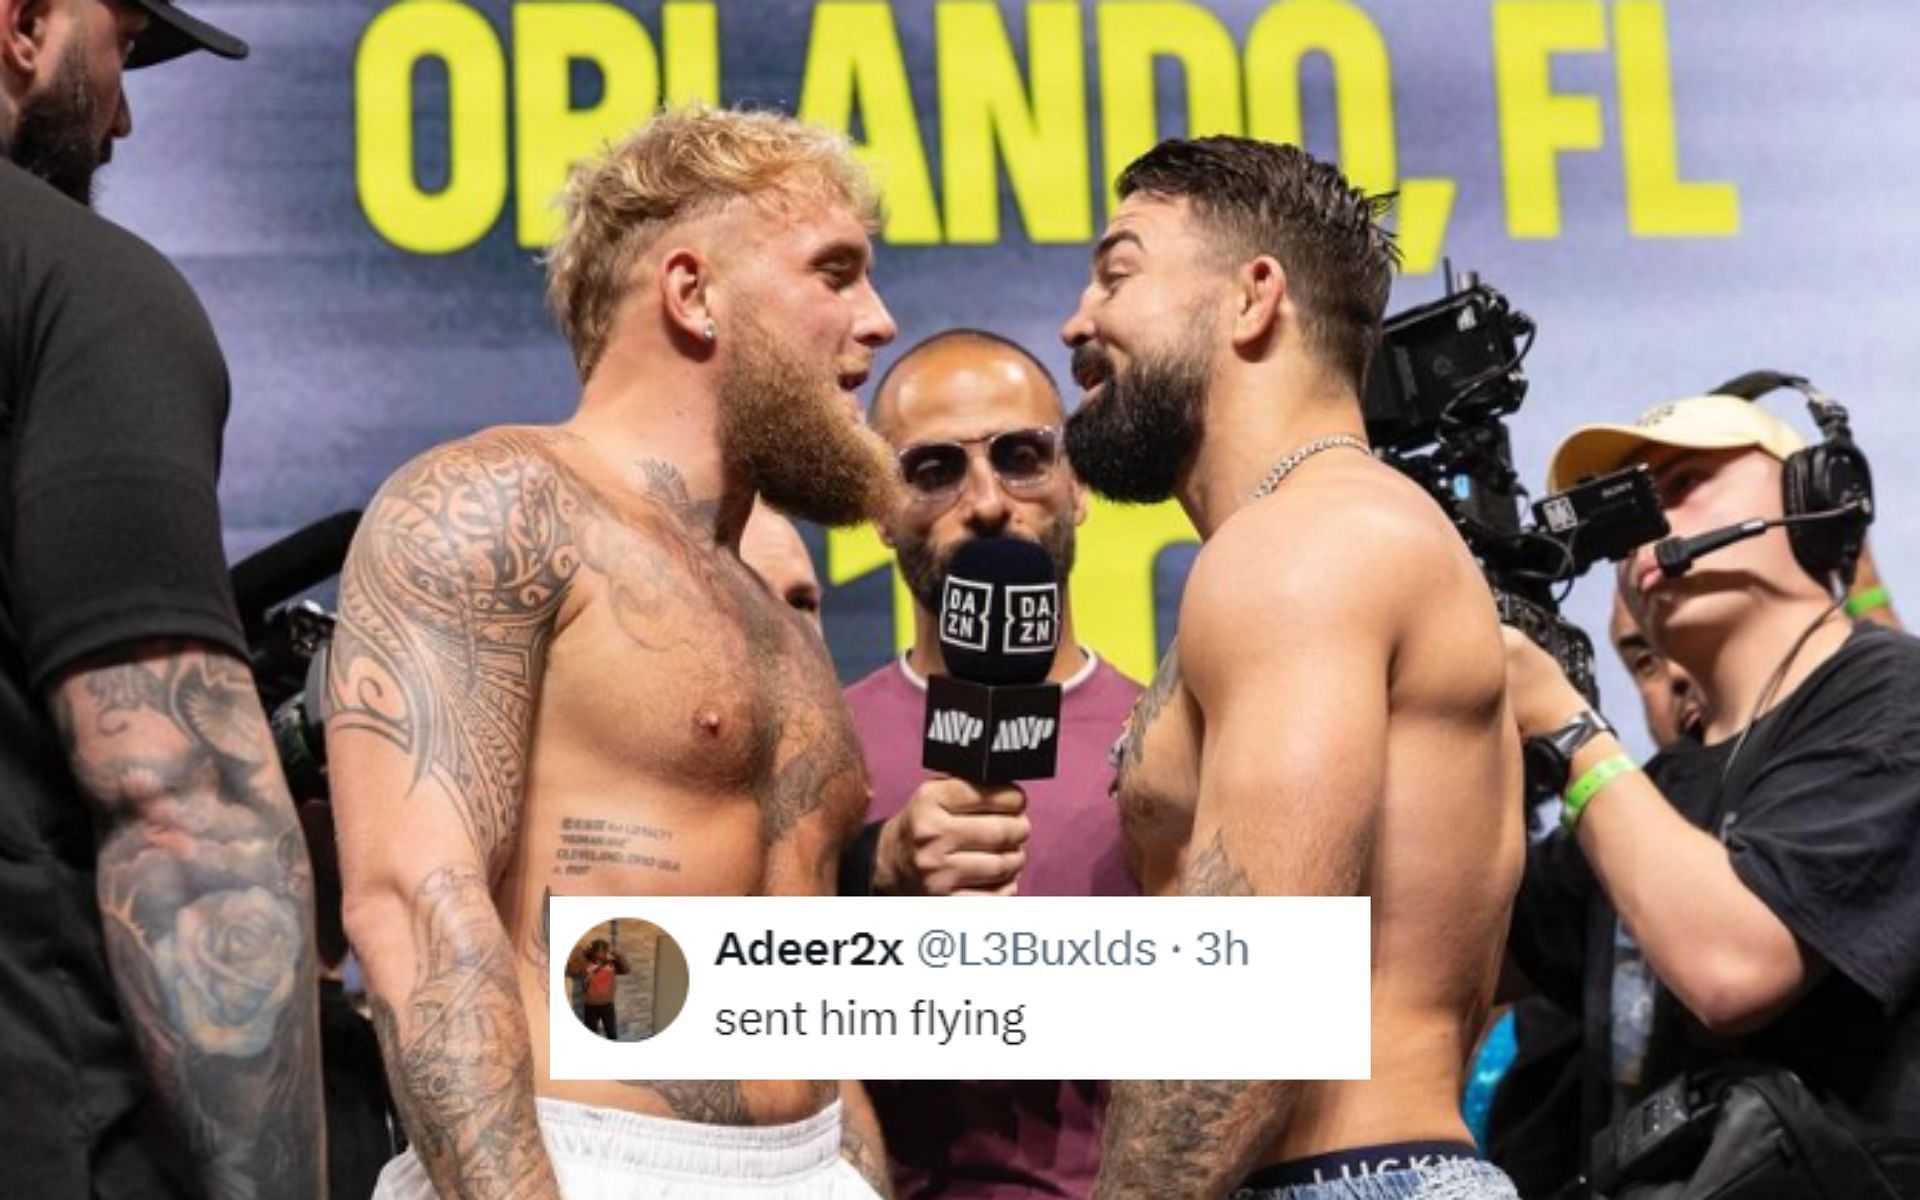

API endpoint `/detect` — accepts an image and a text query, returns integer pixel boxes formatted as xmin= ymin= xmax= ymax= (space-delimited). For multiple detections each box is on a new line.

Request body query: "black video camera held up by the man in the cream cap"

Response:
xmin=1361 ymin=269 xmax=1667 ymax=707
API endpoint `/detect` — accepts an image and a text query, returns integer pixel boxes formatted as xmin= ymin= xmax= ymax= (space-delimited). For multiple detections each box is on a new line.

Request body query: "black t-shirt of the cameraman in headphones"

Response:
xmin=1515 ymin=624 xmax=1920 ymax=1171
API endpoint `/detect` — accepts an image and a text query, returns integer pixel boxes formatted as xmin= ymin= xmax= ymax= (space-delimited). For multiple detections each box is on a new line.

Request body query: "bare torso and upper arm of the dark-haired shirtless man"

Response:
xmin=1117 ymin=455 xmax=1524 ymax=1162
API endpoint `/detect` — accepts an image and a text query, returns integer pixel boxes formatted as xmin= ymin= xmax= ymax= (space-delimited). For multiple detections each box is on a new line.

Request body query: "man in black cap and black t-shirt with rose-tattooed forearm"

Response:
xmin=0 ymin=0 xmax=324 ymax=1200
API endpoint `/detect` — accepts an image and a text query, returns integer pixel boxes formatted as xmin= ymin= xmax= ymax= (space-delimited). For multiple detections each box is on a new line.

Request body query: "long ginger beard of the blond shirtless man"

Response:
xmin=720 ymin=315 xmax=895 ymax=526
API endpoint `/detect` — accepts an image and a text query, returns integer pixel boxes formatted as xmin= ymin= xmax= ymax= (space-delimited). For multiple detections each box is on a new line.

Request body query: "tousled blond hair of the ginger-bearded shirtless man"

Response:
xmin=547 ymin=106 xmax=879 ymax=378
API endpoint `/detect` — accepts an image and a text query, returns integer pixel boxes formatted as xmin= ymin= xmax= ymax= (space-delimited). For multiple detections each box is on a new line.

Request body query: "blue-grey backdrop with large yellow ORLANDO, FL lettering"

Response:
xmin=102 ymin=0 xmax=1920 ymax=747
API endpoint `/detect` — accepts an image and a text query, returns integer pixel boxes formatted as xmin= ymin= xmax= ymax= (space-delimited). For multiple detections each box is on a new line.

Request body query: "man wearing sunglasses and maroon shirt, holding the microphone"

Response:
xmin=847 ymin=330 xmax=1139 ymax=1198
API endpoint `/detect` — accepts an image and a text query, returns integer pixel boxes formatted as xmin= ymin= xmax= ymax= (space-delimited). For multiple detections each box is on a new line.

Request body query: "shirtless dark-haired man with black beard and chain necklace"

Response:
xmin=1062 ymin=138 xmax=1524 ymax=1200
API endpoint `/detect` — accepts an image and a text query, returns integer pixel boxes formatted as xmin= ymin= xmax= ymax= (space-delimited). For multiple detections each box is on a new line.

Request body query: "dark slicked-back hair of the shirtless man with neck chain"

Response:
xmin=1116 ymin=136 xmax=1400 ymax=390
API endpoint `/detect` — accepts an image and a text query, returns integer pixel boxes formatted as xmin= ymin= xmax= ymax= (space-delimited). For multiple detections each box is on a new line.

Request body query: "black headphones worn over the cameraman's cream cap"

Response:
xmin=1715 ymin=371 xmax=1874 ymax=589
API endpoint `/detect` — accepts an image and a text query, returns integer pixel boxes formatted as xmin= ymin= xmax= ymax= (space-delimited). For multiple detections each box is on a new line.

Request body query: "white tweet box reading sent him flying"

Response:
xmin=549 ymin=897 xmax=1373 ymax=1079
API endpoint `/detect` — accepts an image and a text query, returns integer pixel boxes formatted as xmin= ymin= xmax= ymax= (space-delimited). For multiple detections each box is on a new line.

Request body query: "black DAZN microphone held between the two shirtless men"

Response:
xmin=920 ymin=538 xmax=1060 ymax=783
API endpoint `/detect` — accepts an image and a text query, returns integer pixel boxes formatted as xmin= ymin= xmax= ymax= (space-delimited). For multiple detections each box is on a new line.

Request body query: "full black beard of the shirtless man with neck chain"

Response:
xmin=1066 ymin=328 xmax=1213 ymax=505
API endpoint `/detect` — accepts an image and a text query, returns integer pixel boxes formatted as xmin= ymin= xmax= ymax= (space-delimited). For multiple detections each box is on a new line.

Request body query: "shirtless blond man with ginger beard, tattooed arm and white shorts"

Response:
xmin=328 ymin=109 xmax=895 ymax=1200
